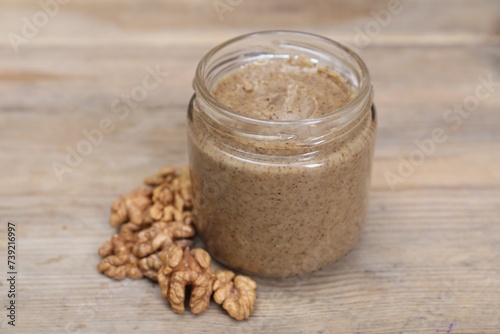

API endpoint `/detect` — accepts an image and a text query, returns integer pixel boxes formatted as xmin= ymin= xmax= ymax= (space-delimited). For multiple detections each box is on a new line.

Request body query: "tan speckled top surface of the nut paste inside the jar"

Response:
xmin=212 ymin=60 xmax=354 ymax=120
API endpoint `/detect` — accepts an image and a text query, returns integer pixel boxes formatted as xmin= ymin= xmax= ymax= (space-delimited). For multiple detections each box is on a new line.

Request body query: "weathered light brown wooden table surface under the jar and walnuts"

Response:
xmin=0 ymin=0 xmax=500 ymax=333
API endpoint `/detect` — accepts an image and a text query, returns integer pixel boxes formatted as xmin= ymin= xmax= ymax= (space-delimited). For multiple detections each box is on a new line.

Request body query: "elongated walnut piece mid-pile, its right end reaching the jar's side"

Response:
xmin=133 ymin=222 xmax=195 ymax=258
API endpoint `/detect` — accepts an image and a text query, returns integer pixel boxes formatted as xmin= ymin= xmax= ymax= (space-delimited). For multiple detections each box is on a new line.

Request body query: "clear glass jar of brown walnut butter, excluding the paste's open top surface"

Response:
xmin=188 ymin=31 xmax=376 ymax=277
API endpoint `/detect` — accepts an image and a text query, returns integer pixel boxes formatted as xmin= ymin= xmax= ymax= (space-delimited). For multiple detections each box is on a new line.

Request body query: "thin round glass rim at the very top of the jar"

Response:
xmin=193 ymin=30 xmax=371 ymax=126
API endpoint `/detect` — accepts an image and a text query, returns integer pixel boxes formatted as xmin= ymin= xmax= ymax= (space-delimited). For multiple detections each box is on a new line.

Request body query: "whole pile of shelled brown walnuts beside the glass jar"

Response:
xmin=97 ymin=167 xmax=257 ymax=320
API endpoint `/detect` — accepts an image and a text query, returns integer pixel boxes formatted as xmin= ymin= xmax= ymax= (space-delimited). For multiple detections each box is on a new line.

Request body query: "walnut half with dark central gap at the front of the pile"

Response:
xmin=158 ymin=245 xmax=214 ymax=314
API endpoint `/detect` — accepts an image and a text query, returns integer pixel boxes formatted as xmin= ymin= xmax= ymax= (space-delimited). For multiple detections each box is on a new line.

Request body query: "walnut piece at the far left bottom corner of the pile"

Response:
xmin=97 ymin=234 xmax=143 ymax=280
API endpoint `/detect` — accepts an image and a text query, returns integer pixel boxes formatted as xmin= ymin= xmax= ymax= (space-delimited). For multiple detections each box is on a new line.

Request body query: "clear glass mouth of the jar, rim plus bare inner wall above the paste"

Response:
xmin=193 ymin=30 xmax=371 ymax=126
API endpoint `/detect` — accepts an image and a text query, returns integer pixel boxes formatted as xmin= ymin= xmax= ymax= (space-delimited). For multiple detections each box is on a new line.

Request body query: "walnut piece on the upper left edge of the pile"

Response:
xmin=109 ymin=188 xmax=153 ymax=227
